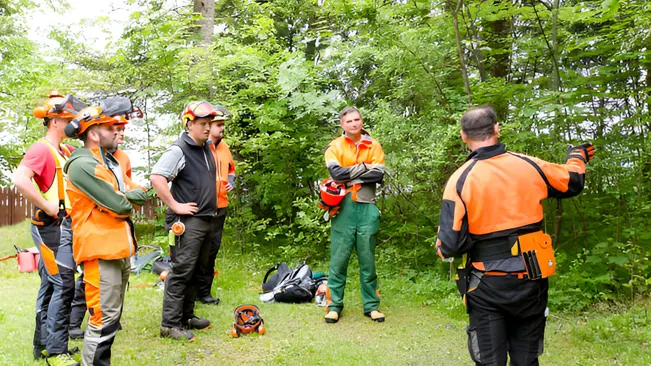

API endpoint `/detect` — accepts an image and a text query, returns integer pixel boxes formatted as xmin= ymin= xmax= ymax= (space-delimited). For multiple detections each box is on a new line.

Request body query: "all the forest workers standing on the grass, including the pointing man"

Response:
xmin=14 ymin=89 xmax=595 ymax=365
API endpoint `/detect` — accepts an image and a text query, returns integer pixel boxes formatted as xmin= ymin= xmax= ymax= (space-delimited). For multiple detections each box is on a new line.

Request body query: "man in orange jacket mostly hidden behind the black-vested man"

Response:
xmin=197 ymin=105 xmax=235 ymax=305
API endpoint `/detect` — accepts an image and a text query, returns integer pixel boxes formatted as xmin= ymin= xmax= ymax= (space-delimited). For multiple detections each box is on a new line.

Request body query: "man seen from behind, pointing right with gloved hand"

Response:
xmin=436 ymin=107 xmax=595 ymax=365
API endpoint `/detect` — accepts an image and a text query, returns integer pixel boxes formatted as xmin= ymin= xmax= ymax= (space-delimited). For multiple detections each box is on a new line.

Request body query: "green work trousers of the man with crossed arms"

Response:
xmin=328 ymin=194 xmax=380 ymax=313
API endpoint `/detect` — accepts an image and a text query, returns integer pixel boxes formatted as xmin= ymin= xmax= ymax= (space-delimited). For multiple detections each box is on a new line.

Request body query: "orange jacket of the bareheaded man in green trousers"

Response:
xmin=325 ymin=131 xmax=384 ymax=203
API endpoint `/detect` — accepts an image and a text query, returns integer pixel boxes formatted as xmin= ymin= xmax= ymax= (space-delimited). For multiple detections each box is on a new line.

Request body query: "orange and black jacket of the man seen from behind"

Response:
xmin=436 ymin=143 xmax=586 ymax=272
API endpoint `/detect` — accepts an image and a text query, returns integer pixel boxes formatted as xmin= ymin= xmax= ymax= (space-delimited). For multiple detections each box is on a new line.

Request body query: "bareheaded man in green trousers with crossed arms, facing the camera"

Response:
xmin=325 ymin=107 xmax=384 ymax=323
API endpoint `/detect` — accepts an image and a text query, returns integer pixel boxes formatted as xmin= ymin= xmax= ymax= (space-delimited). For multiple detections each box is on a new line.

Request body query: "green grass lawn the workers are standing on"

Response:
xmin=0 ymin=223 xmax=651 ymax=366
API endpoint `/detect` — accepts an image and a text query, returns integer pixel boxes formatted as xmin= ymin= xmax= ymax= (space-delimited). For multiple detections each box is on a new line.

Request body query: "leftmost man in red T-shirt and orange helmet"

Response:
xmin=13 ymin=91 xmax=85 ymax=365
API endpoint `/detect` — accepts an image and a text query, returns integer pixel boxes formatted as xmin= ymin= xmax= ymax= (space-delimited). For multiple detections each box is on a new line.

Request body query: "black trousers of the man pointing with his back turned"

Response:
xmin=466 ymin=271 xmax=549 ymax=366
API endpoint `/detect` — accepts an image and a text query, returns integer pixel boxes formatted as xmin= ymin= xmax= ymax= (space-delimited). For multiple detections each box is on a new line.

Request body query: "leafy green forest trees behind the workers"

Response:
xmin=0 ymin=0 xmax=651 ymax=310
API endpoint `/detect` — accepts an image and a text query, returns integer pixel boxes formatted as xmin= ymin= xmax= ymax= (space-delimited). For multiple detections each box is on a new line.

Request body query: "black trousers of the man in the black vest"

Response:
xmin=161 ymin=215 xmax=217 ymax=328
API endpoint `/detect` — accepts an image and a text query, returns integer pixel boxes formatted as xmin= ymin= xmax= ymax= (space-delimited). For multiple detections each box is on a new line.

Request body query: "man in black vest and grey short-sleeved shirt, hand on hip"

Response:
xmin=150 ymin=101 xmax=223 ymax=340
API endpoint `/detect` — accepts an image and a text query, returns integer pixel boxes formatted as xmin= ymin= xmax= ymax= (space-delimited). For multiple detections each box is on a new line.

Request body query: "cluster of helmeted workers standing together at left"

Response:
xmin=14 ymin=91 xmax=235 ymax=365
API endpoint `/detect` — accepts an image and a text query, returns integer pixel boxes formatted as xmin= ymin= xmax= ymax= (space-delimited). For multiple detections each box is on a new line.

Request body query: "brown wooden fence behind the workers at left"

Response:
xmin=0 ymin=187 xmax=162 ymax=227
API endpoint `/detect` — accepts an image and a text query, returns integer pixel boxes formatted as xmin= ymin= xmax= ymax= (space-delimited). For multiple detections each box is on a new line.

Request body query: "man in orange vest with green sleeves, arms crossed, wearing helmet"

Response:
xmin=64 ymin=100 xmax=147 ymax=365
